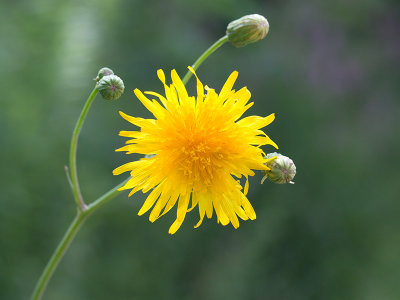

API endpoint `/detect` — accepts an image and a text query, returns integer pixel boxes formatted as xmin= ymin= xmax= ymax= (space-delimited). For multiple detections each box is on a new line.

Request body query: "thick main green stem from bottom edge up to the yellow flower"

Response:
xmin=31 ymin=178 xmax=129 ymax=300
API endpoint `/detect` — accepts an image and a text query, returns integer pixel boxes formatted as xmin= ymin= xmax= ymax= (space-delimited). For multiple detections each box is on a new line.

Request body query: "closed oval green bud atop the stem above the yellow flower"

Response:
xmin=226 ymin=14 xmax=269 ymax=47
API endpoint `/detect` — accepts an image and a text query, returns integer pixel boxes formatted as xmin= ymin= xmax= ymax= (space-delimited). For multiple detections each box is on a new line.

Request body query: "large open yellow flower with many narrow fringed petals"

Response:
xmin=113 ymin=67 xmax=278 ymax=234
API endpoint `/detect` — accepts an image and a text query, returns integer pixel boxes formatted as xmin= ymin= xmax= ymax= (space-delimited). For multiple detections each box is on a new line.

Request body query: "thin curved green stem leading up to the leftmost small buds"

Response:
xmin=69 ymin=87 xmax=98 ymax=211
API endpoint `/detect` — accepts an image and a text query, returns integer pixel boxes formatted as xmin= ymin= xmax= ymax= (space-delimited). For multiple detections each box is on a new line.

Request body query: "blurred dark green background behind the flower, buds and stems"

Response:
xmin=0 ymin=0 xmax=400 ymax=300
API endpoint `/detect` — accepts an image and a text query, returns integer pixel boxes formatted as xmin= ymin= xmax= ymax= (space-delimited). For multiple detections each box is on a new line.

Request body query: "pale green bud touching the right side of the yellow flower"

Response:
xmin=261 ymin=152 xmax=296 ymax=184
